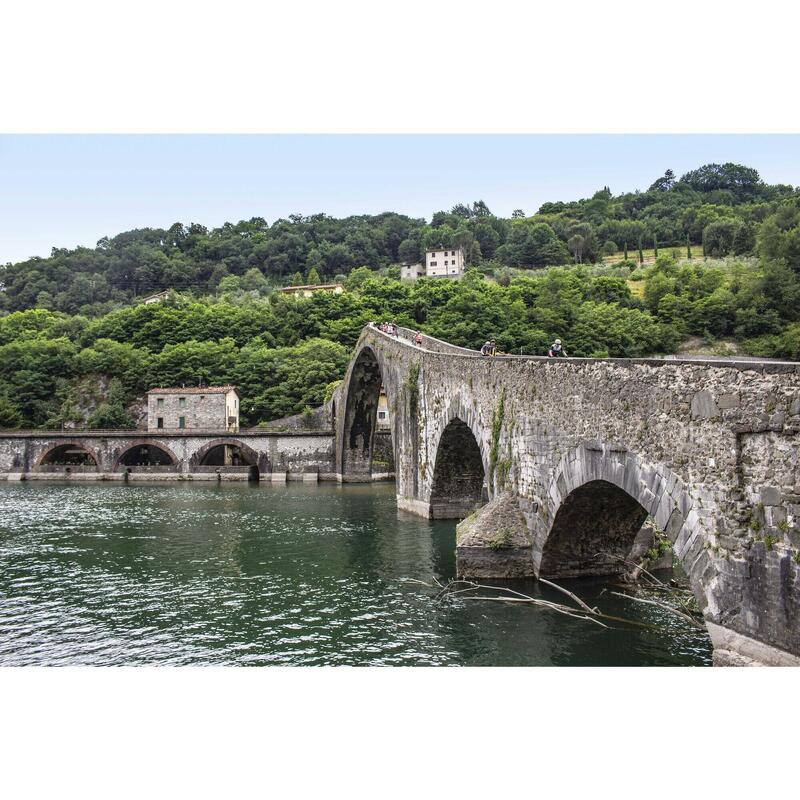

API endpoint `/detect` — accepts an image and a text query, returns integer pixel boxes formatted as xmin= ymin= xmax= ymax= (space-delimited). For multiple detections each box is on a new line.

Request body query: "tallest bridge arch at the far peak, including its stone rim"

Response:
xmin=336 ymin=343 xmax=402 ymax=481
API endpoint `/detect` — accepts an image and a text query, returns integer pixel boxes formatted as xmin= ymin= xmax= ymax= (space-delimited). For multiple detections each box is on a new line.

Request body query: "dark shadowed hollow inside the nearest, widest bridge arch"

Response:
xmin=539 ymin=480 xmax=647 ymax=578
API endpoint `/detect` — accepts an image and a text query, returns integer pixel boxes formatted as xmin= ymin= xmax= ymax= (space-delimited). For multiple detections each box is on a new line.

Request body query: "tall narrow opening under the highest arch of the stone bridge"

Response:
xmin=342 ymin=347 xmax=394 ymax=480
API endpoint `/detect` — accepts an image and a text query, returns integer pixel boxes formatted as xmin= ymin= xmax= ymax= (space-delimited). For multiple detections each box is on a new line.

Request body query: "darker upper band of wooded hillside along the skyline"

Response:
xmin=0 ymin=159 xmax=798 ymax=316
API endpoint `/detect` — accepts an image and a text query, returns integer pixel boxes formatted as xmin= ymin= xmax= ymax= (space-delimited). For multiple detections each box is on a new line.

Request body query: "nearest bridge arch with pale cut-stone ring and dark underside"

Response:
xmin=533 ymin=444 xmax=718 ymax=616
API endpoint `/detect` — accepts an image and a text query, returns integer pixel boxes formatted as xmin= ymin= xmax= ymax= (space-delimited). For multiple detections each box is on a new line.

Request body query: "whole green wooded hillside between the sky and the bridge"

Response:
xmin=0 ymin=159 xmax=800 ymax=428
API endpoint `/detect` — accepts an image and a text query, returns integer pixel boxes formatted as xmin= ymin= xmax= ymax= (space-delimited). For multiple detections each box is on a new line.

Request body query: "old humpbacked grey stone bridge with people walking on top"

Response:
xmin=333 ymin=326 xmax=800 ymax=664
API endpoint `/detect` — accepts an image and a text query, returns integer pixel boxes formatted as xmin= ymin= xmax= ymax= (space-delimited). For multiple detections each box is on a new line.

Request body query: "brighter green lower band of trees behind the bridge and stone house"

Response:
xmin=0 ymin=253 xmax=800 ymax=427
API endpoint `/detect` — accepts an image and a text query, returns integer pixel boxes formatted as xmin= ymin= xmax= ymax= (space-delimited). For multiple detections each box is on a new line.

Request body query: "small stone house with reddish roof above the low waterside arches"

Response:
xmin=147 ymin=386 xmax=239 ymax=431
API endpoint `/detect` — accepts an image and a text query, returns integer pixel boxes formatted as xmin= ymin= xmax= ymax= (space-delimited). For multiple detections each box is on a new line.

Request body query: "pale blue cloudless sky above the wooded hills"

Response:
xmin=0 ymin=134 xmax=800 ymax=263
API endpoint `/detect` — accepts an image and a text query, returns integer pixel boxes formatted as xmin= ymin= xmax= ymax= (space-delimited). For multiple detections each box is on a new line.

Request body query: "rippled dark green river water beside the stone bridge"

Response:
xmin=0 ymin=482 xmax=711 ymax=666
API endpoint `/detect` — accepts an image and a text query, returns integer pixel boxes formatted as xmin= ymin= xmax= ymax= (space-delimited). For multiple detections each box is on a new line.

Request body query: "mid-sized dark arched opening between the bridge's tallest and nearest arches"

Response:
xmin=430 ymin=417 xmax=486 ymax=519
